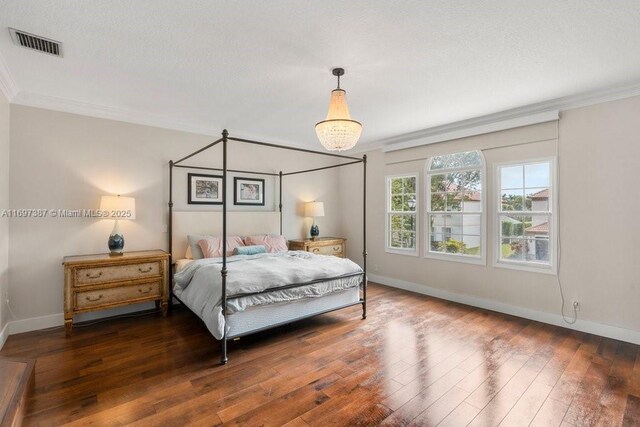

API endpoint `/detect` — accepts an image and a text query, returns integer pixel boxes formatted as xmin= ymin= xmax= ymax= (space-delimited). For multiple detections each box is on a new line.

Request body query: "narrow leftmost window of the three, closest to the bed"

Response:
xmin=387 ymin=175 xmax=418 ymax=255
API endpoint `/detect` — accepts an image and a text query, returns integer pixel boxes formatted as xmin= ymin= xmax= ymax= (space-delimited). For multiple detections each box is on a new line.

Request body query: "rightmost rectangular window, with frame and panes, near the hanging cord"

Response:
xmin=496 ymin=160 xmax=556 ymax=272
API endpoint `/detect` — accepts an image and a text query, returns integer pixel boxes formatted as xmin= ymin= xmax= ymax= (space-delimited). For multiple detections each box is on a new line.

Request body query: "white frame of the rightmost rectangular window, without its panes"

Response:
xmin=493 ymin=156 xmax=559 ymax=275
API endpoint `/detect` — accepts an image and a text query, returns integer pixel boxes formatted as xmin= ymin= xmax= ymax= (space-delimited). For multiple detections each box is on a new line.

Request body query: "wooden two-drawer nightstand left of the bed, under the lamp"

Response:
xmin=63 ymin=250 xmax=169 ymax=335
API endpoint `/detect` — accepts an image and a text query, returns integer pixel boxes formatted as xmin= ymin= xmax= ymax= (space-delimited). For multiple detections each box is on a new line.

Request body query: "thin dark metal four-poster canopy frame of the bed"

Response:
xmin=168 ymin=129 xmax=367 ymax=364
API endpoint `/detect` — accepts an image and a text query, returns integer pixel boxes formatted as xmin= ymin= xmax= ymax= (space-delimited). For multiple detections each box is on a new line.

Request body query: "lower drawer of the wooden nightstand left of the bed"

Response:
xmin=74 ymin=280 xmax=162 ymax=310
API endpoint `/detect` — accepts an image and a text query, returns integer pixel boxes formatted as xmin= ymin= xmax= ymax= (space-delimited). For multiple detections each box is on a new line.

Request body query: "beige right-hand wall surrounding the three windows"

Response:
xmin=341 ymin=97 xmax=640 ymax=341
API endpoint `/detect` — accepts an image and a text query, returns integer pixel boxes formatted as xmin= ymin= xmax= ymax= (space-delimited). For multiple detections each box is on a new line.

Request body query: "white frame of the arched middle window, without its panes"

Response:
xmin=423 ymin=150 xmax=487 ymax=265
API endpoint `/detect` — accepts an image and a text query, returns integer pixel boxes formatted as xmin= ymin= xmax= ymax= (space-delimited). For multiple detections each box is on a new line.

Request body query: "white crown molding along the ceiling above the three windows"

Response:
xmin=378 ymin=83 xmax=640 ymax=152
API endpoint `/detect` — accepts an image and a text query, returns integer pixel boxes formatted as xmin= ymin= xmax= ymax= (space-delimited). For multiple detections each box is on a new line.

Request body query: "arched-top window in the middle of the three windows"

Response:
xmin=425 ymin=151 xmax=485 ymax=264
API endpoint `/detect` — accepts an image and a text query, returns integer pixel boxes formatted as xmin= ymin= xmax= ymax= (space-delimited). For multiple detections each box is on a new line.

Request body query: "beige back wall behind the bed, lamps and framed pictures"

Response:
xmin=9 ymin=105 xmax=340 ymax=332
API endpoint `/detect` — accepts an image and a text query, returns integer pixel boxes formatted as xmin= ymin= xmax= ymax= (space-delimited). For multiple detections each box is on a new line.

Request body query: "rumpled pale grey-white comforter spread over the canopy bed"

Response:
xmin=173 ymin=251 xmax=362 ymax=339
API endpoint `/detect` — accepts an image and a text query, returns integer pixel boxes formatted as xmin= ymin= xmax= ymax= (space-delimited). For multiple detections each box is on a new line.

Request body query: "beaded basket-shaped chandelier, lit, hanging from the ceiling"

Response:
xmin=316 ymin=68 xmax=362 ymax=151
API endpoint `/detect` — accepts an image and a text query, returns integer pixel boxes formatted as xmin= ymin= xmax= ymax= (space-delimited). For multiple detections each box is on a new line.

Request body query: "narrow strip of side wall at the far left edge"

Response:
xmin=0 ymin=88 xmax=9 ymax=347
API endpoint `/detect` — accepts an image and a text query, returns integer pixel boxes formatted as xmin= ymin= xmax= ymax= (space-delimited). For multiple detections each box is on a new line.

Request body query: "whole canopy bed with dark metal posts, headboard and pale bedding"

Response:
xmin=169 ymin=130 xmax=367 ymax=364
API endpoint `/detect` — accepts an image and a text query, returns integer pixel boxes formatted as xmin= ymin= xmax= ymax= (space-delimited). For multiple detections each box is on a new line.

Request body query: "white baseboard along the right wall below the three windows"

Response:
xmin=367 ymin=274 xmax=640 ymax=345
